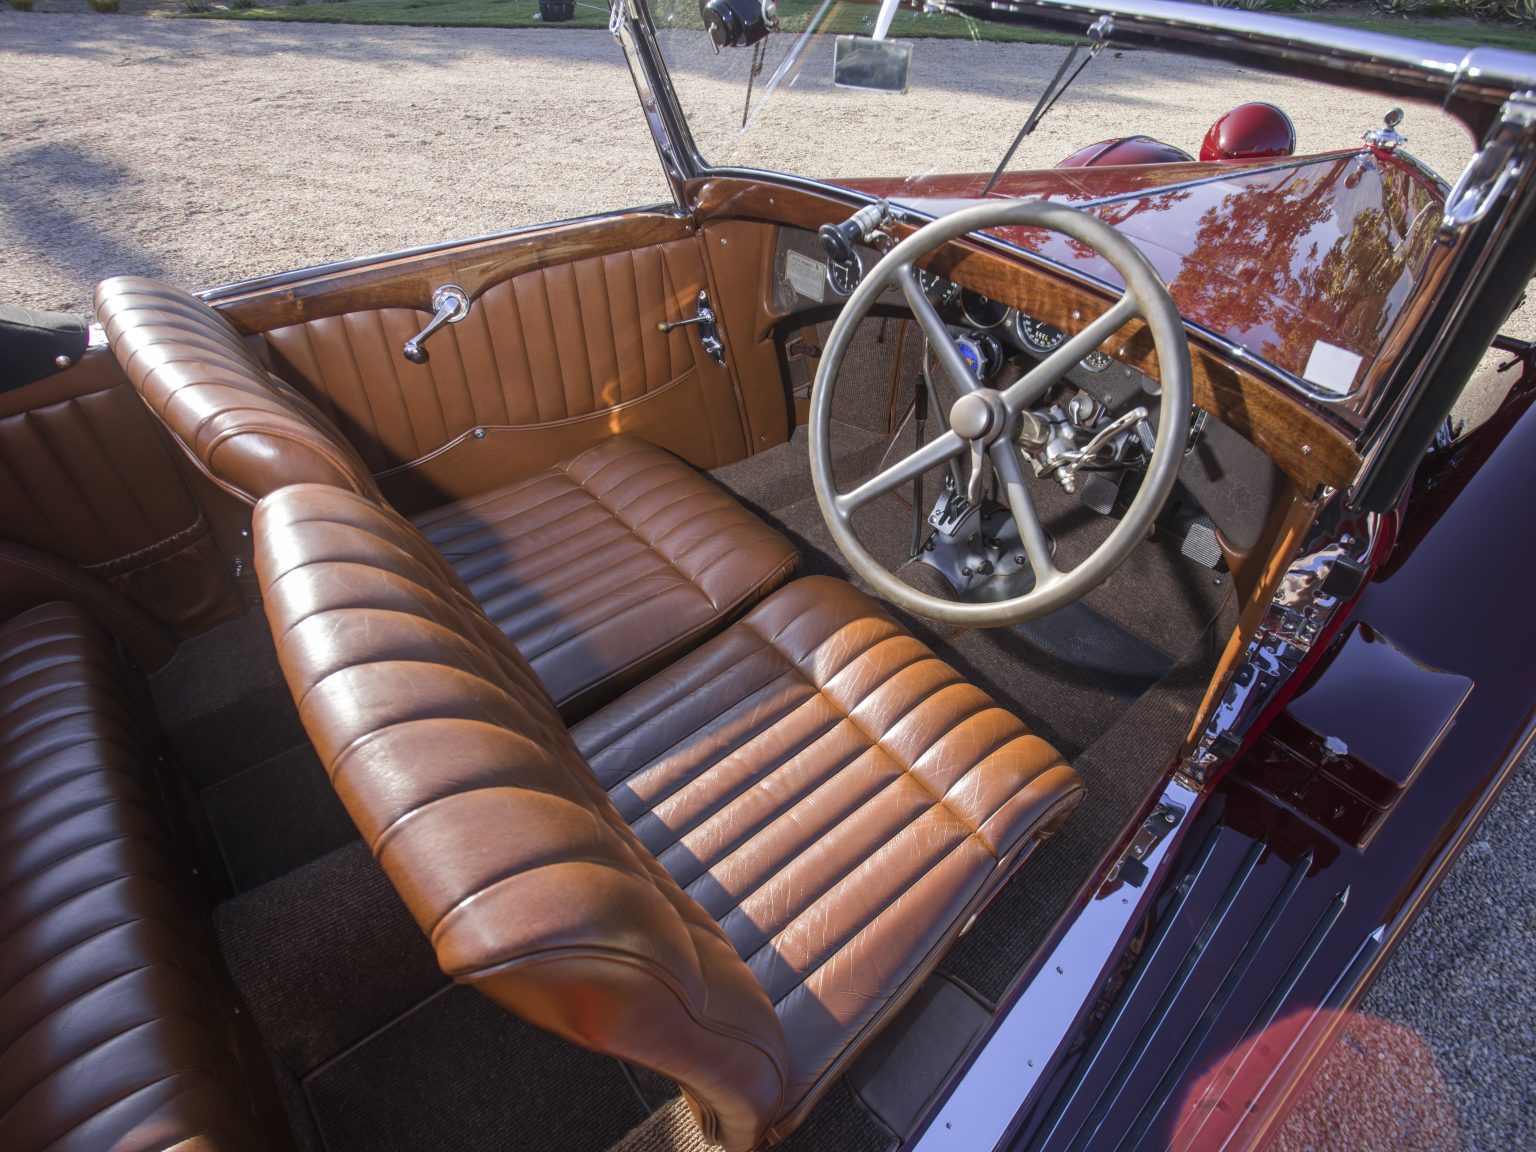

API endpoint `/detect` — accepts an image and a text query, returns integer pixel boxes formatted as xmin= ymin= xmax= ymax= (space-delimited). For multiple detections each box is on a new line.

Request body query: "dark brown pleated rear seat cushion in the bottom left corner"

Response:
xmin=0 ymin=604 xmax=287 ymax=1152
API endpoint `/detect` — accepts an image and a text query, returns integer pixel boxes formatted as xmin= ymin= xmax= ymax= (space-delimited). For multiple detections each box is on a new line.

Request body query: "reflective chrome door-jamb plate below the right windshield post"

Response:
xmin=1181 ymin=498 xmax=1379 ymax=785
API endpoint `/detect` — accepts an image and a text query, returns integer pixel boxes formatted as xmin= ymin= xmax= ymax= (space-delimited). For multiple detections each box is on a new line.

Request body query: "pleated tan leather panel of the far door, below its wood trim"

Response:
xmin=264 ymin=235 xmax=750 ymax=510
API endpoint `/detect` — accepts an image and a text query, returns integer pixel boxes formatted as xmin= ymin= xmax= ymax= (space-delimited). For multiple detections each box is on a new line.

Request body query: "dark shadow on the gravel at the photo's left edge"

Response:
xmin=0 ymin=144 xmax=166 ymax=293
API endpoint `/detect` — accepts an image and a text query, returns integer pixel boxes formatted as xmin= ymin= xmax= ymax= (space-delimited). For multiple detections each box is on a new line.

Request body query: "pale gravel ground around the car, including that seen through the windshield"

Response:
xmin=0 ymin=9 xmax=1536 ymax=1152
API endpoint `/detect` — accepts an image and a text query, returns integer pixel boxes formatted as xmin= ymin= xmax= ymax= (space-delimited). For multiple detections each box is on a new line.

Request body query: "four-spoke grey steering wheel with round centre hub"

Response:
xmin=811 ymin=200 xmax=1192 ymax=628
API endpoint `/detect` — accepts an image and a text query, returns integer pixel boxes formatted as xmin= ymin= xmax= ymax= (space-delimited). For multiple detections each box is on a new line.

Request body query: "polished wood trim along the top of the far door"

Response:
xmin=214 ymin=212 xmax=694 ymax=335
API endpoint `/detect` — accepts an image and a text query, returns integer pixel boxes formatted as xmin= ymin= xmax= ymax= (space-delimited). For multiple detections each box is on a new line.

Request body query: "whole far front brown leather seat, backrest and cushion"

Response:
xmin=97 ymin=276 xmax=799 ymax=717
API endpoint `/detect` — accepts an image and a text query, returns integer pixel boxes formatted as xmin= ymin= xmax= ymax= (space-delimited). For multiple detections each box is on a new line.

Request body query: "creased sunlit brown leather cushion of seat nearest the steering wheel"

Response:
xmin=571 ymin=578 xmax=1081 ymax=1135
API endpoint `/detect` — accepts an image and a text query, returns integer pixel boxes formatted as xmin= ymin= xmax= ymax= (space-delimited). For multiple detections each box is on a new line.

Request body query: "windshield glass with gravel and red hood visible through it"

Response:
xmin=653 ymin=0 xmax=1471 ymax=401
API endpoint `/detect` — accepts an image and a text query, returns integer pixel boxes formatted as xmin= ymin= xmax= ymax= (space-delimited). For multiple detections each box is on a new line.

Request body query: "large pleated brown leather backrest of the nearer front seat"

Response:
xmin=255 ymin=484 xmax=786 ymax=1149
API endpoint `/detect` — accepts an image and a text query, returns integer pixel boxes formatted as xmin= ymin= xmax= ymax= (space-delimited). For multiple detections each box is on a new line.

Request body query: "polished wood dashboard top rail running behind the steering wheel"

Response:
xmin=687 ymin=177 xmax=1361 ymax=487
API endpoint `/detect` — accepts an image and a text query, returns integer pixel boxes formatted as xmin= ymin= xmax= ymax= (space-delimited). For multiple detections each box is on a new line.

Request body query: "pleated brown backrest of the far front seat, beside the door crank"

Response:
xmin=95 ymin=276 xmax=378 ymax=504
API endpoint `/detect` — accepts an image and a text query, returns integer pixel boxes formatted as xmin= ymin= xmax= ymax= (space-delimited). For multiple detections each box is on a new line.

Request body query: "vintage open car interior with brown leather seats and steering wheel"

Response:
xmin=0 ymin=2 xmax=1536 ymax=1152
